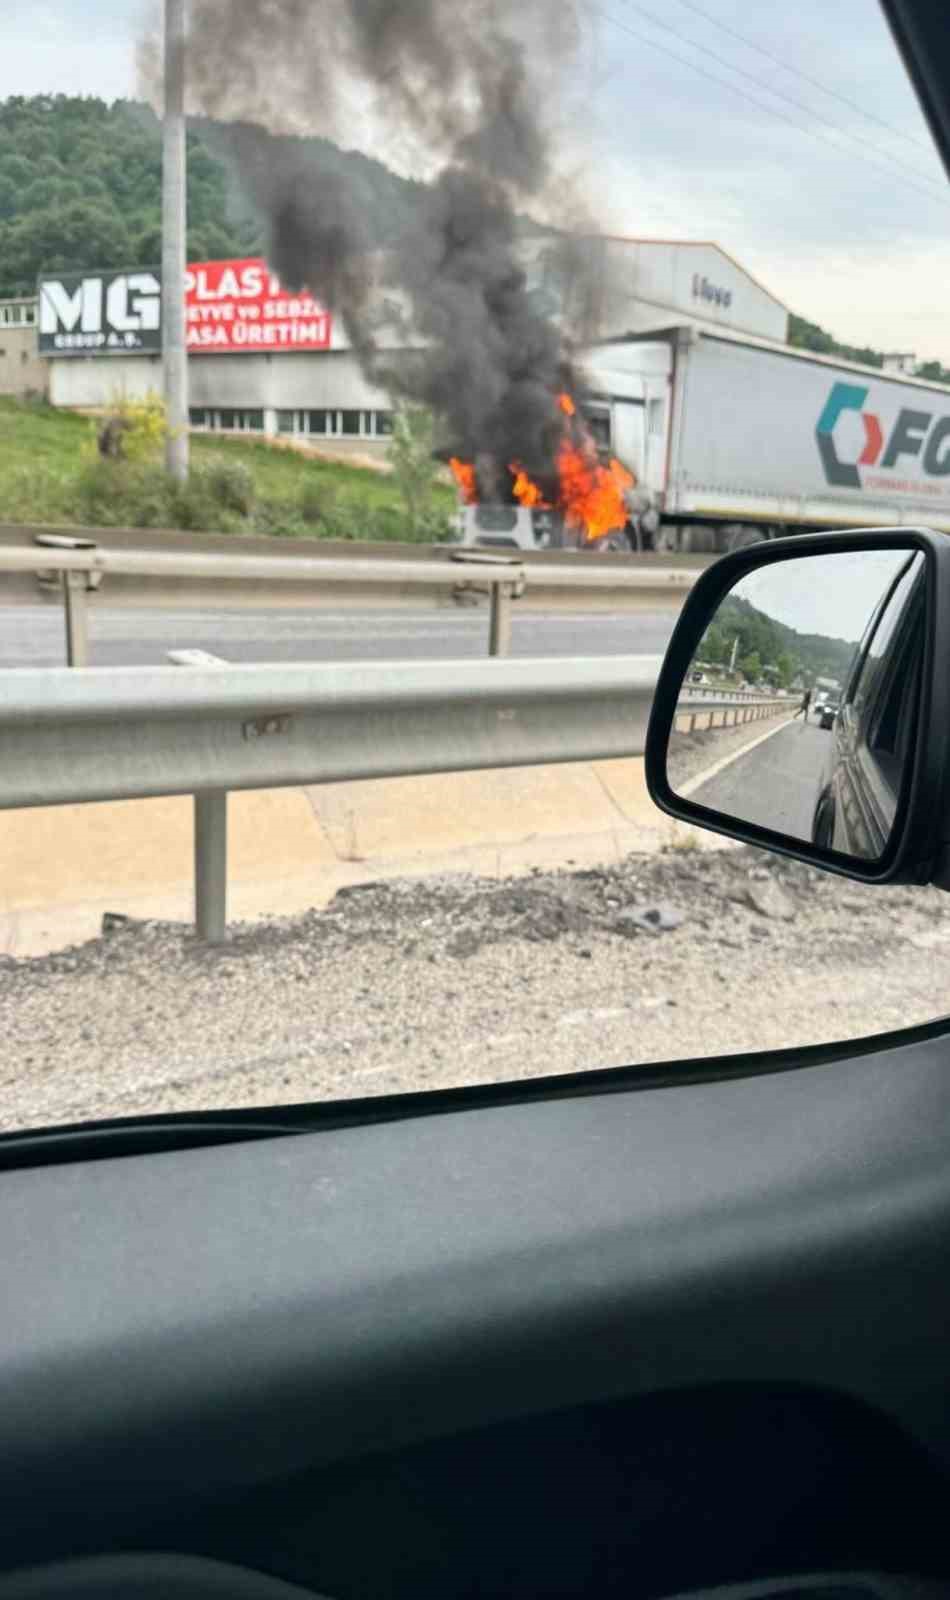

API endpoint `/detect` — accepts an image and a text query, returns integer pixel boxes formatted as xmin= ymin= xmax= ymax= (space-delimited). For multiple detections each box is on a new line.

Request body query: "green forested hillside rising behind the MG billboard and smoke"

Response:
xmin=0 ymin=94 xmax=416 ymax=298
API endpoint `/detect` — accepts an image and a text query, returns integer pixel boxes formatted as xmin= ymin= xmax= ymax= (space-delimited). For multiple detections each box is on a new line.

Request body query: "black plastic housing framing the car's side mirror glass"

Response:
xmin=646 ymin=528 xmax=950 ymax=888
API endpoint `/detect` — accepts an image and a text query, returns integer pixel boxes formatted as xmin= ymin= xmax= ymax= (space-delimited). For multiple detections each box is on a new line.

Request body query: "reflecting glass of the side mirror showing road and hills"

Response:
xmin=667 ymin=546 xmax=926 ymax=861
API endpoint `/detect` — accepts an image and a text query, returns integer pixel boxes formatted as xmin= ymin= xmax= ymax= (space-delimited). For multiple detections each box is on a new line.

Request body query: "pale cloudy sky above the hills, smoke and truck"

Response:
xmin=7 ymin=0 xmax=950 ymax=365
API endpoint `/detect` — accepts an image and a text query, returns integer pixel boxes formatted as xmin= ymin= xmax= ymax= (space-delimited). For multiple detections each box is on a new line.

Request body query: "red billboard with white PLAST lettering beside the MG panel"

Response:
xmin=186 ymin=258 xmax=333 ymax=355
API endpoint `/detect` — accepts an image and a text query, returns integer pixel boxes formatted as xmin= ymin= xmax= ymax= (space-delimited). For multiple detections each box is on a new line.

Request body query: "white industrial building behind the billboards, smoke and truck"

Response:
xmin=29 ymin=235 xmax=788 ymax=451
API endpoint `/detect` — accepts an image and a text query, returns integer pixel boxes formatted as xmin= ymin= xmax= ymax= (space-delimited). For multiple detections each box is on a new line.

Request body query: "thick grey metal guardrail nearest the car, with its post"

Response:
xmin=0 ymin=656 xmax=659 ymax=942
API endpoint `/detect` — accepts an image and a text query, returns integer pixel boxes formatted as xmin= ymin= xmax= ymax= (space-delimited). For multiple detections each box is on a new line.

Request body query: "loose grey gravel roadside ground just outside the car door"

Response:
xmin=0 ymin=850 xmax=950 ymax=1128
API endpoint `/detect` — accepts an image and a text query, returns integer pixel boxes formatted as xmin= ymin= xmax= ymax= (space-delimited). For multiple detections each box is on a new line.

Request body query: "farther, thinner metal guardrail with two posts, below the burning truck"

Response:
xmin=0 ymin=530 xmax=696 ymax=666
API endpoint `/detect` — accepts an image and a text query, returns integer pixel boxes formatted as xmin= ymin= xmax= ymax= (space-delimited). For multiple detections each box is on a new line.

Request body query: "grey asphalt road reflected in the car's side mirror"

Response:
xmin=689 ymin=718 xmax=833 ymax=842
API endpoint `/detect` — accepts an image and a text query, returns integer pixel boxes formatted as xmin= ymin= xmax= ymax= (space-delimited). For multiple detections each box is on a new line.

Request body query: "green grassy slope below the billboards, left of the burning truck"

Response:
xmin=0 ymin=398 xmax=454 ymax=539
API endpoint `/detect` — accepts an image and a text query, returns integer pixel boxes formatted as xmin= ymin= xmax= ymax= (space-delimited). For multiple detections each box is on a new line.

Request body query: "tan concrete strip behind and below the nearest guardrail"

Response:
xmin=0 ymin=760 xmax=728 ymax=953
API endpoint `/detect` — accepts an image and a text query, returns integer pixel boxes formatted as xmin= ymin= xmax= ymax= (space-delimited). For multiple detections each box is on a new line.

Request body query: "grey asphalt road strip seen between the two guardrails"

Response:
xmin=0 ymin=605 xmax=675 ymax=669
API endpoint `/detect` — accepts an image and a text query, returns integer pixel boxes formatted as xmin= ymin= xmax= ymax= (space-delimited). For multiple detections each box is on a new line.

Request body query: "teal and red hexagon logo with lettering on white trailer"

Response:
xmin=814 ymin=384 xmax=950 ymax=490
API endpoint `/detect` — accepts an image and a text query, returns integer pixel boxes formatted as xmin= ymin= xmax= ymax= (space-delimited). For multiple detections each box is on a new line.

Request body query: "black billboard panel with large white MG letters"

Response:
xmin=37 ymin=267 xmax=162 ymax=355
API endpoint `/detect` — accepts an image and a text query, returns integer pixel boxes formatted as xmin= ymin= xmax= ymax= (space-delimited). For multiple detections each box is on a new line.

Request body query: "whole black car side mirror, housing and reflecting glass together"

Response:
xmin=646 ymin=528 xmax=950 ymax=886
